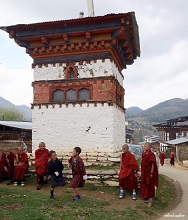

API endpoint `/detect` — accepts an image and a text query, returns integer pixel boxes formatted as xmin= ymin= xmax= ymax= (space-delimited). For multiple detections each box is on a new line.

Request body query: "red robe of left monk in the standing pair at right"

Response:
xmin=119 ymin=151 xmax=139 ymax=190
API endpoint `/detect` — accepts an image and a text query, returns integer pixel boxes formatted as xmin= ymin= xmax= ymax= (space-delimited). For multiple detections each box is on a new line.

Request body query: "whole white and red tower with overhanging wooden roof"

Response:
xmin=3 ymin=12 xmax=140 ymax=154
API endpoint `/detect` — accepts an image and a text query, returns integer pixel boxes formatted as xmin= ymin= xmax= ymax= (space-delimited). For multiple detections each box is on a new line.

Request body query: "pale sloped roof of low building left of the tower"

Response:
xmin=0 ymin=121 xmax=32 ymax=130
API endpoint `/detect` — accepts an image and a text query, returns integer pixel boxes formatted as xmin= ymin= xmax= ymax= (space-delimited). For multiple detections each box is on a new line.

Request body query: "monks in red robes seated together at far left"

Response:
xmin=0 ymin=147 xmax=29 ymax=186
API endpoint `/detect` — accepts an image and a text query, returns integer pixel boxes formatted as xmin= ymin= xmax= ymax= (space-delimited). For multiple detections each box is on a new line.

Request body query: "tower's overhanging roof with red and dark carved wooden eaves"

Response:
xmin=0 ymin=12 xmax=140 ymax=71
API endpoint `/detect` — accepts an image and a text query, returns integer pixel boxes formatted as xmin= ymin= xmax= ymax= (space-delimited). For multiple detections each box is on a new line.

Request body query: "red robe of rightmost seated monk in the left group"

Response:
xmin=14 ymin=153 xmax=29 ymax=180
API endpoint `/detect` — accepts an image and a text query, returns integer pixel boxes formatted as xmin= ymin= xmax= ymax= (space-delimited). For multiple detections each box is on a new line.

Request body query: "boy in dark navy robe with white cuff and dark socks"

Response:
xmin=48 ymin=150 xmax=66 ymax=199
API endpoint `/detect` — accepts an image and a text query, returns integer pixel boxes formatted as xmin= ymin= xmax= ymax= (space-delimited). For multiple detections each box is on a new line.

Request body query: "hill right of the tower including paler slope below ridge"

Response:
xmin=126 ymin=98 xmax=188 ymax=144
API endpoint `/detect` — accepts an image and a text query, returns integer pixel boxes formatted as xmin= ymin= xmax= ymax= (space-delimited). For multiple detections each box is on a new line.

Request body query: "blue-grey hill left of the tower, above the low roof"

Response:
xmin=0 ymin=97 xmax=32 ymax=121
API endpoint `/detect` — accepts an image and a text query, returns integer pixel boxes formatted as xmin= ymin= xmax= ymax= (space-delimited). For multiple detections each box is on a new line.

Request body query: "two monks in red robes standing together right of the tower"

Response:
xmin=119 ymin=143 xmax=158 ymax=204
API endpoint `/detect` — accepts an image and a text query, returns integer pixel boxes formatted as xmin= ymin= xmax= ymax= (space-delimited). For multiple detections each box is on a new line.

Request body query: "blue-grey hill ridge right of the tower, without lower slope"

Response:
xmin=126 ymin=98 xmax=188 ymax=122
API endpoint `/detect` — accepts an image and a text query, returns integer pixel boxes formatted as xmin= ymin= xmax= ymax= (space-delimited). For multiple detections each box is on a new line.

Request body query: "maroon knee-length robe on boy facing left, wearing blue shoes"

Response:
xmin=69 ymin=156 xmax=86 ymax=188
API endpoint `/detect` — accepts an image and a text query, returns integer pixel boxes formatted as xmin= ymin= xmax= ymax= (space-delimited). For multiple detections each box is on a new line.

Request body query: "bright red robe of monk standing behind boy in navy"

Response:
xmin=34 ymin=149 xmax=49 ymax=175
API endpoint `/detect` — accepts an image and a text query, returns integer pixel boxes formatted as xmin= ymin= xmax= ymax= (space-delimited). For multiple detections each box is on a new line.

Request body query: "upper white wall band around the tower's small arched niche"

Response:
xmin=34 ymin=59 xmax=123 ymax=86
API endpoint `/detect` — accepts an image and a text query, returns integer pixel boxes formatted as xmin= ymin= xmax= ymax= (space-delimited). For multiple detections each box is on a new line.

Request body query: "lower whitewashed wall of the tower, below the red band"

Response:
xmin=32 ymin=104 xmax=125 ymax=154
